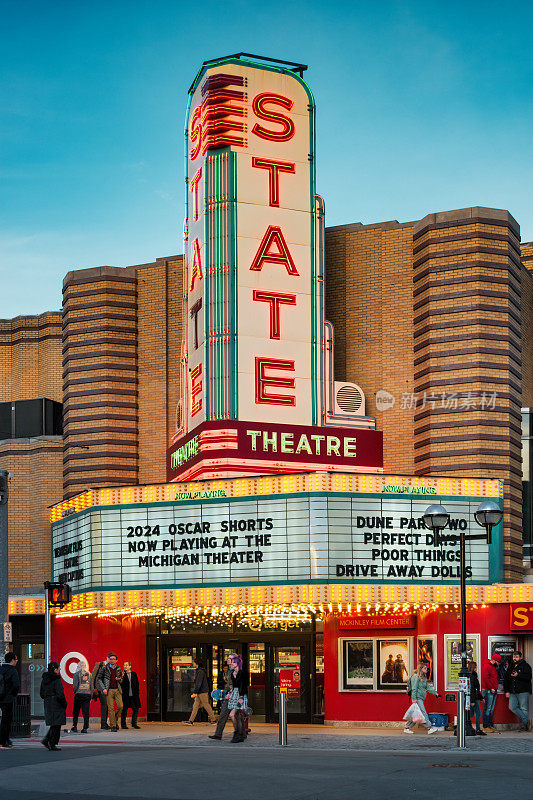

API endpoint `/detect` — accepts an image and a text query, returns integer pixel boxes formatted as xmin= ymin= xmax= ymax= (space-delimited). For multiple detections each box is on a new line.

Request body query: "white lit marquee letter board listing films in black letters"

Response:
xmin=52 ymin=494 xmax=497 ymax=592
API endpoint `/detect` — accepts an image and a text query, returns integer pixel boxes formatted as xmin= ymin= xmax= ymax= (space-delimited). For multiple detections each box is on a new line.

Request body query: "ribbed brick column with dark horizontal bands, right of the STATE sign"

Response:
xmin=413 ymin=207 xmax=523 ymax=580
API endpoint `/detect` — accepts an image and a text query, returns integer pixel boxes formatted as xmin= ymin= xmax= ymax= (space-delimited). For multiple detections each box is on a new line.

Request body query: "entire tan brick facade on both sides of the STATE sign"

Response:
xmin=0 ymin=208 xmax=533 ymax=585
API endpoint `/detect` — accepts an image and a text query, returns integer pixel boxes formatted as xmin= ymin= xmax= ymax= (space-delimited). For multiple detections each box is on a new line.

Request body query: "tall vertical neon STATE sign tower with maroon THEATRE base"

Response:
xmin=168 ymin=56 xmax=383 ymax=480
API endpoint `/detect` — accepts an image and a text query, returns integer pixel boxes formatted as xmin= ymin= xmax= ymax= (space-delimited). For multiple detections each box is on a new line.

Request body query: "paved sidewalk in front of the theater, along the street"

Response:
xmin=25 ymin=722 xmax=533 ymax=754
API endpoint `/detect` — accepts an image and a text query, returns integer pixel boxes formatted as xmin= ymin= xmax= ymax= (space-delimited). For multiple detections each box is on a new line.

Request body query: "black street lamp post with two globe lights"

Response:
xmin=422 ymin=500 xmax=503 ymax=748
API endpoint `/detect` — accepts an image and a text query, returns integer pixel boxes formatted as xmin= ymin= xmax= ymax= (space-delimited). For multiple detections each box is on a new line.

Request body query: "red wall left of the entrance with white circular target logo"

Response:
xmin=51 ymin=617 xmax=146 ymax=718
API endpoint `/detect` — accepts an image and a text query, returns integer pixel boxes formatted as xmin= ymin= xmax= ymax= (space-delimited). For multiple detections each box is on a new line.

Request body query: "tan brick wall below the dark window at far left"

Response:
xmin=0 ymin=436 xmax=63 ymax=589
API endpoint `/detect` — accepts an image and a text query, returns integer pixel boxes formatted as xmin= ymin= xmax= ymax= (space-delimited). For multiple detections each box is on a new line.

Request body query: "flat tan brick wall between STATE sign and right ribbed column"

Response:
xmin=326 ymin=222 xmax=414 ymax=474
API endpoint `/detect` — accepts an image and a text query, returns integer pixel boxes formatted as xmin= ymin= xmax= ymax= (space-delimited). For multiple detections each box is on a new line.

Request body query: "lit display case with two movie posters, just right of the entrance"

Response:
xmin=339 ymin=636 xmax=413 ymax=692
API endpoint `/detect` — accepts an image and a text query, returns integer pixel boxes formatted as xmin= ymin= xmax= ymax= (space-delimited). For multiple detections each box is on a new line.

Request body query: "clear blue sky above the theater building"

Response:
xmin=0 ymin=0 xmax=533 ymax=318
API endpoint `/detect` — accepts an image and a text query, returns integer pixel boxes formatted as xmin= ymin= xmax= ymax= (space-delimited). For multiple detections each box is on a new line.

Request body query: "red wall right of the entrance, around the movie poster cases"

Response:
xmin=324 ymin=605 xmax=520 ymax=723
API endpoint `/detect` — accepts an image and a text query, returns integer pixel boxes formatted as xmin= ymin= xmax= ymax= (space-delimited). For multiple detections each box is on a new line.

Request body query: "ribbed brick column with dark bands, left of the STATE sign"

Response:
xmin=63 ymin=267 xmax=138 ymax=497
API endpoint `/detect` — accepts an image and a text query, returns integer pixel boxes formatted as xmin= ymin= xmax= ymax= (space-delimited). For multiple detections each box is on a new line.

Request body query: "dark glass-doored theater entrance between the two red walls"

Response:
xmin=147 ymin=621 xmax=323 ymax=722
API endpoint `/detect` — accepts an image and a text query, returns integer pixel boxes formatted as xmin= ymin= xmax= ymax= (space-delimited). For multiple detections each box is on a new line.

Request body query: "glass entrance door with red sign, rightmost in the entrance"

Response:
xmin=272 ymin=645 xmax=311 ymax=722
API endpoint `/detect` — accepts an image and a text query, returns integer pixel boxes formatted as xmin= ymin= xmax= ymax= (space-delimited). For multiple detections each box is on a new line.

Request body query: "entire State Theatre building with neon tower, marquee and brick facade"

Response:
xmin=0 ymin=57 xmax=533 ymax=724
